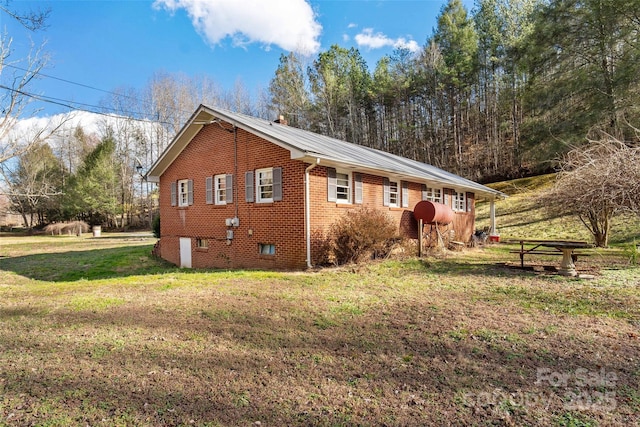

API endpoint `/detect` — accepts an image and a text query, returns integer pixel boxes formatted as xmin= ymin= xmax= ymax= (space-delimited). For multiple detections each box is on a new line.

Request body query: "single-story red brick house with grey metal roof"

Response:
xmin=147 ymin=105 xmax=502 ymax=269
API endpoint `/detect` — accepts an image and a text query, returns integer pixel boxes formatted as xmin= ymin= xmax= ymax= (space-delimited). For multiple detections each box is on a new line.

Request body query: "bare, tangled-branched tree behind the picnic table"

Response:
xmin=540 ymin=135 xmax=640 ymax=247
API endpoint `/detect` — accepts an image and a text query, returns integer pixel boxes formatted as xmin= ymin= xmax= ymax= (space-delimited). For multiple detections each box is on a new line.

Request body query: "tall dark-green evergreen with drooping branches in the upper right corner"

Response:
xmin=527 ymin=0 xmax=640 ymax=152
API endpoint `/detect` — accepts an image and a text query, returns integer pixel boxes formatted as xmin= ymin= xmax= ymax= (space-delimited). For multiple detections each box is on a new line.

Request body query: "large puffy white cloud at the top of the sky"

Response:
xmin=153 ymin=0 xmax=322 ymax=54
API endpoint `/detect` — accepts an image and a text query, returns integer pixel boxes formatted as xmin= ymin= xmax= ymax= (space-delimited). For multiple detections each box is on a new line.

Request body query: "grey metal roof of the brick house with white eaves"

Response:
xmin=147 ymin=105 xmax=506 ymax=199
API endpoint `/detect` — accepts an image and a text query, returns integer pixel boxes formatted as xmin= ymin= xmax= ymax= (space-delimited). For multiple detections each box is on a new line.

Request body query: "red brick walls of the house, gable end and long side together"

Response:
xmin=160 ymin=123 xmax=474 ymax=269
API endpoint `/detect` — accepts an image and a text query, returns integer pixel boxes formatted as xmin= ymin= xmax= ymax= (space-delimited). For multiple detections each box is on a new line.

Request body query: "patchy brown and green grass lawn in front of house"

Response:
xmin=0 ymin=237 xmax=640 ymax=426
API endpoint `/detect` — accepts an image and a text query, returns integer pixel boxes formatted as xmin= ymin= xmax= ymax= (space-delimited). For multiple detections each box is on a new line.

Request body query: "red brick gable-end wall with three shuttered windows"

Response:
xmin=160 ymin=124 xmax=306 ymax=269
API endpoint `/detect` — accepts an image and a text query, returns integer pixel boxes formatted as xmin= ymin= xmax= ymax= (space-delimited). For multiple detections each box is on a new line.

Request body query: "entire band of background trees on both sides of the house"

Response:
xmin=0 ymin=0 xmax=640 ymax=234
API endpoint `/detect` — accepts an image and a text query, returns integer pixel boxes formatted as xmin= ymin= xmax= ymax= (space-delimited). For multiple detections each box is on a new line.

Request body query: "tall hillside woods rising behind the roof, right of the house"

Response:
xmin=270 ymin=0 xmax=640 ymax=182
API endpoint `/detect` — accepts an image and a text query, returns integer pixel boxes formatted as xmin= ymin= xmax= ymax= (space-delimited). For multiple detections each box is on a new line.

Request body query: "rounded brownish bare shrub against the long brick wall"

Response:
xmin=330 ymin=207 xmax=398 ymax=264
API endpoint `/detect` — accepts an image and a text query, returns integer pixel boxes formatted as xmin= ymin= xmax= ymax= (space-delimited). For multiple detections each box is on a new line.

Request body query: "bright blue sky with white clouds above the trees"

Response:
xmin=0 ymin=0 xmax=473 ymax=115
